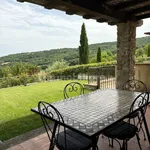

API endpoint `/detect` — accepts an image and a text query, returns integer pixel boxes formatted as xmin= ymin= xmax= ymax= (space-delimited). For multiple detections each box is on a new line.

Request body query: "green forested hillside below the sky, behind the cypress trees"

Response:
xmin=0 ymin=36 xmax=150 ymax=69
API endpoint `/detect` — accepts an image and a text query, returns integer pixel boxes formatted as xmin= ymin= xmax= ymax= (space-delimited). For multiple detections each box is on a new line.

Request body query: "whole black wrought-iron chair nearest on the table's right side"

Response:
xmin=103 ymin=92 xmax=149 ymax=150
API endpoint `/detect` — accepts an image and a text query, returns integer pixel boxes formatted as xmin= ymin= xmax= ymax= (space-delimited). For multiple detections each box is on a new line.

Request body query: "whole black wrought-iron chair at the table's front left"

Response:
xmin=38 ymin=101 xmax=92 ymax=150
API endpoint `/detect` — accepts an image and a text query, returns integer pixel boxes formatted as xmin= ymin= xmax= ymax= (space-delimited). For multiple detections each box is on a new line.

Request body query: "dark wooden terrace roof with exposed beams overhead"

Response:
xmin=17 ymin=0 xmax=150 ymax=25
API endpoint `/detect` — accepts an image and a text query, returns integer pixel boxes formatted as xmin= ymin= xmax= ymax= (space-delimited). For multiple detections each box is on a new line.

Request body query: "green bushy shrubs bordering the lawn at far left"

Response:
xmin=0 ymin=63 xmax=39 ymax=88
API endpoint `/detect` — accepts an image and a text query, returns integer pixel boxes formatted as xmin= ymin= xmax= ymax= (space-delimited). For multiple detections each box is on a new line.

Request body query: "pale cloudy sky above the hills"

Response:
xmin=0 ymin=0 xmax=150 ymax=56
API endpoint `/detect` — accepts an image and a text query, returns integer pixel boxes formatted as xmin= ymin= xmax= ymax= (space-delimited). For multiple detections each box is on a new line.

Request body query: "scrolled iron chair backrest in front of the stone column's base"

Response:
xmin=122 ymin=79 xmax=147 ymax=92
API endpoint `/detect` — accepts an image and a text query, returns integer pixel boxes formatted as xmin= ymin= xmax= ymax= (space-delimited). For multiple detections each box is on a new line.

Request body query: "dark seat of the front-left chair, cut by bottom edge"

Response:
xmin=55 ymin=130 xmax=92 ymax=150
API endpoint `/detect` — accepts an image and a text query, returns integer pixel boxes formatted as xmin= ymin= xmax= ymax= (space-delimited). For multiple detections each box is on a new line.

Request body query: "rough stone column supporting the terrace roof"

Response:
xmin=116 ymin=21 xmax=137 ymax=89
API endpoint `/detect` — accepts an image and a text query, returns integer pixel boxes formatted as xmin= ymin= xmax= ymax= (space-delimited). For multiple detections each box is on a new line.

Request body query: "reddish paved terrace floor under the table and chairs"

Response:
xmin=7 ymin=107 xmax=150 ymax=150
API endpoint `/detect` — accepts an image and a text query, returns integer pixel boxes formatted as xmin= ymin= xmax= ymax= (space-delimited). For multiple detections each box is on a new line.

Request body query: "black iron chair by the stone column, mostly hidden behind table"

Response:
xmin=122 ymin=79 xmax=147 ymax=140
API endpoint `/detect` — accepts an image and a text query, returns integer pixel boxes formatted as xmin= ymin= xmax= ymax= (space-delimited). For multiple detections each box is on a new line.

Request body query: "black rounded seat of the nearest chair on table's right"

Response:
xmin=103 ymin=121 xmax=138 ymax=140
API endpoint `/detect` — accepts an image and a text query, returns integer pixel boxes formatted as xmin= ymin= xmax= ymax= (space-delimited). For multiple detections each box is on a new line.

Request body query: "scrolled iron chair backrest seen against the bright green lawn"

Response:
xmin=64 ymin=82 xmax=84 ymax=99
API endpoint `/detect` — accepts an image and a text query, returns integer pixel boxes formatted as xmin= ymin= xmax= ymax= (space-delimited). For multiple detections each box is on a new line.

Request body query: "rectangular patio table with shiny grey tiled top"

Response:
xmin=31 ymin=89 xmax=150 ymax=149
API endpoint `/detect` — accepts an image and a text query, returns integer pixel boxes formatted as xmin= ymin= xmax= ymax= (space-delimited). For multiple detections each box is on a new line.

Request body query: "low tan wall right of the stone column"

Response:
xmin=135 ymin=63 xmax=150 ymax=92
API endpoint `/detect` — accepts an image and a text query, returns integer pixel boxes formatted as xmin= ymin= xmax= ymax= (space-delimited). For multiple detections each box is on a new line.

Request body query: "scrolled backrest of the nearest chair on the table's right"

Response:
xmin=128 ymin=92 xmax=149 ymax=130
